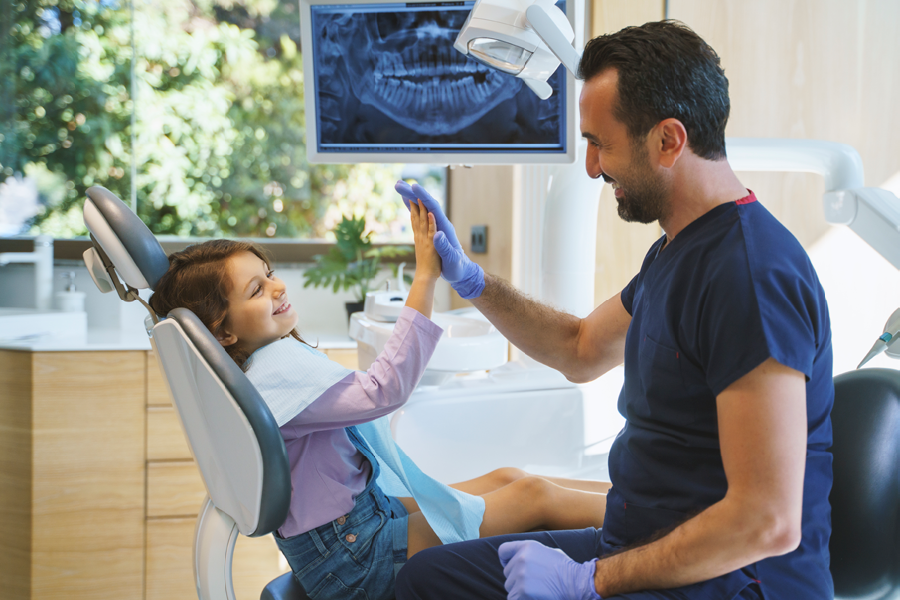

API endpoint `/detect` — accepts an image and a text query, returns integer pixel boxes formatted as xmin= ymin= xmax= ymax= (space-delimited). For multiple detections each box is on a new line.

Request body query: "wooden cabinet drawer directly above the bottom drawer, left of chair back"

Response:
xmin=147 ymin=461 xmax=206 ymax=517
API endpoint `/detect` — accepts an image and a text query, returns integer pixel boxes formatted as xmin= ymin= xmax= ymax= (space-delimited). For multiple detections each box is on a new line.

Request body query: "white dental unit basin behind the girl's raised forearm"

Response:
xmin=350 ymin=313 xmax=509 ymax=385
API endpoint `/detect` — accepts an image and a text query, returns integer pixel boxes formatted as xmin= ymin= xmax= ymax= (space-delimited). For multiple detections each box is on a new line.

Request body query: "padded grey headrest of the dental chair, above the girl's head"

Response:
xmin=84 ymin=186 xmax=169 ymax=290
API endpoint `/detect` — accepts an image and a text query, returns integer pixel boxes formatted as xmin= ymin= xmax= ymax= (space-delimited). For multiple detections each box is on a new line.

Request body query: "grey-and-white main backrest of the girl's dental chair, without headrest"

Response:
xmin=153 ymin=308 xmax=291 ymax=536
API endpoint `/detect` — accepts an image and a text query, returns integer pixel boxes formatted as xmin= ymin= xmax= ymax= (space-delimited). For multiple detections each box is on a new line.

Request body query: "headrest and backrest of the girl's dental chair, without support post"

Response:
xmin=84 ymin=187 xmax=291 ymax=536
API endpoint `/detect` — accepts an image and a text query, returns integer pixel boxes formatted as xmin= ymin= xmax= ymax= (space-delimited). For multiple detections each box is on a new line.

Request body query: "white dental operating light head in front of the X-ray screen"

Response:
xmin=453 ymin=0 xmax=581 ymax=100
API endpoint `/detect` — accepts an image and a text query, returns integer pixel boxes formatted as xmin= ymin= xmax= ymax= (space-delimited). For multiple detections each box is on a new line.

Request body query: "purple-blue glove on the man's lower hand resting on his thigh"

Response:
xmin=499 ymin=540 xmax=603 ymax=600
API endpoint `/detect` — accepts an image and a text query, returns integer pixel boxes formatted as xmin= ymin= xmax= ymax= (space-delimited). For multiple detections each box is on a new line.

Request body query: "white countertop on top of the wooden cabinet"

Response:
xmin=0 ymin=329 xmax=356 ymax=352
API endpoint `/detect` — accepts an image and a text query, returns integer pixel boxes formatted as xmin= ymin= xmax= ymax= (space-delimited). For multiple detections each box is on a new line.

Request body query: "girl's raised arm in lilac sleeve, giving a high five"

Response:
xmin=282 ymin=199 xmax=443 ymax=437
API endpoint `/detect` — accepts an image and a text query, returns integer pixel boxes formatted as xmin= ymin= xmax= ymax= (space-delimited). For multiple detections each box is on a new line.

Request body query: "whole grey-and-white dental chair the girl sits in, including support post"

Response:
xmin=84 ymin=187 xmax=308 ymax=600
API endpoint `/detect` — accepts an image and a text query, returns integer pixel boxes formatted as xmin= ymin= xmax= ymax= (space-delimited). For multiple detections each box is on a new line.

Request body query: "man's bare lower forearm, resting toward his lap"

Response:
xmin=594 ymin=500 xmax=796 ymax=598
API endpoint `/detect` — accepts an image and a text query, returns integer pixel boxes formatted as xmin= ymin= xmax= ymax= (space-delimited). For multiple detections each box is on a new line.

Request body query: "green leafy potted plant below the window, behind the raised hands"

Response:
xmin=303 ymin=215 xmax=412 ymax=319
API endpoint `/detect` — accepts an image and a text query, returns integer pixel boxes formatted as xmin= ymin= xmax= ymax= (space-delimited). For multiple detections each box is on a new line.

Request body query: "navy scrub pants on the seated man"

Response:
xmin=395 ymin=528 xmax=763 ymax=600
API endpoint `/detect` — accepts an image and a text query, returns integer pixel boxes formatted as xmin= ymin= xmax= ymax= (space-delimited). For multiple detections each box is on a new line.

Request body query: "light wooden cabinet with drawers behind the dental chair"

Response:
xmin=0 ymin=350 xmax=356 ymax=600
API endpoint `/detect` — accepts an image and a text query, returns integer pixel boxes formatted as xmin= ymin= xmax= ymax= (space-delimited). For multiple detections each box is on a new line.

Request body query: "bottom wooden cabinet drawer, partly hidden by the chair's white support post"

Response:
xmin=145 ymin=506 xmax=289 ymax=600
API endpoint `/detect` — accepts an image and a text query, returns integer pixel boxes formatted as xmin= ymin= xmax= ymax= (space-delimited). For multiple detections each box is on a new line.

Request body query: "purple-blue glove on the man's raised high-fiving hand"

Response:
xmin=394 ymin=180 xmax=484 ymax=300
